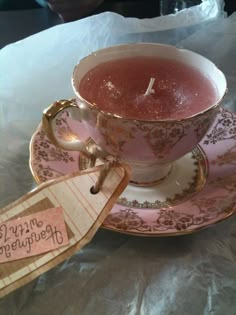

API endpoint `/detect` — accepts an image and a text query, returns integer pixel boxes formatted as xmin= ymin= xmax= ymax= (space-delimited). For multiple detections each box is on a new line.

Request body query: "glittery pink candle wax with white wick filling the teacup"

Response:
xmin=78 ymin=56 xmax=218 ymax=120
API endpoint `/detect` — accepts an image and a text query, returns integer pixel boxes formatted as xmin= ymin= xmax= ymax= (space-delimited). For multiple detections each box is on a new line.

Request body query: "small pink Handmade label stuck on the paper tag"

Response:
xmin=0 ymin=207 xmax=68 ymax=263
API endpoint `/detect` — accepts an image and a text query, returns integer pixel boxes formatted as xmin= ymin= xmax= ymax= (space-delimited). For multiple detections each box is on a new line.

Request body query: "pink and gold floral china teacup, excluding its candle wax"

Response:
xmin=43 ymin=43 xmax=227 ymax=185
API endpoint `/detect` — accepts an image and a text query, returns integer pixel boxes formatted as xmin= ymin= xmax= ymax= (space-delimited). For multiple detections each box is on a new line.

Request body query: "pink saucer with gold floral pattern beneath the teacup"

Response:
xmin=30 ymin=109 xmax=236 ymax=236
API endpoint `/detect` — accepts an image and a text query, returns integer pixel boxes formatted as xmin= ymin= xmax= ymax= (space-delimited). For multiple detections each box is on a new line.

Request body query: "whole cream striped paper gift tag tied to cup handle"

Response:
xmin=0 ymin=166 xmax=129 ymax=297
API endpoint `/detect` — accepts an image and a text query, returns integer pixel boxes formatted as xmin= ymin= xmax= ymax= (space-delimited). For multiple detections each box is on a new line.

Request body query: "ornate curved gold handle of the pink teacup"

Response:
xmin=42 ymin=100 xmax=97 ymax=163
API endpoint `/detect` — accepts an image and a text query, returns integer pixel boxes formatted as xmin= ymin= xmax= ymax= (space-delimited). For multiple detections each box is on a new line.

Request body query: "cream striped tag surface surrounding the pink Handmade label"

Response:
xmin=0 ymin=166 xmax=129 ymax=296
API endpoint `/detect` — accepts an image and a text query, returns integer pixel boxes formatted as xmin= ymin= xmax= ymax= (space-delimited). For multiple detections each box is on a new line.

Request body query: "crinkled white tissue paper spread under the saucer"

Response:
xmin=0 ymin=0 xmax=236 ymax=315
